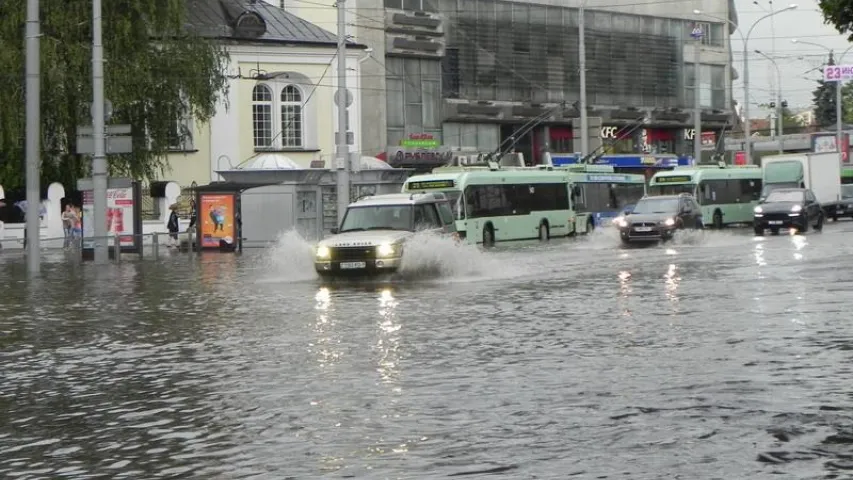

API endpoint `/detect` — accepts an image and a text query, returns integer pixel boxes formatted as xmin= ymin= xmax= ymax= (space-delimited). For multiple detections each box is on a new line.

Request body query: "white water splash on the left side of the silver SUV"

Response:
xmin=262 ymin=229 xmax=317 ymax=282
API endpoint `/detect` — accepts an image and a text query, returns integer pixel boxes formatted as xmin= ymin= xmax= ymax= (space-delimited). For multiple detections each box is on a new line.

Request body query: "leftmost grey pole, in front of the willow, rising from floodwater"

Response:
xmin=24 ymin=0 xmax=41 ymax=275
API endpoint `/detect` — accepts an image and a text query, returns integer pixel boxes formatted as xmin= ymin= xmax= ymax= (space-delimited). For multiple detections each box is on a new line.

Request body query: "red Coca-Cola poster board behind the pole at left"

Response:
xmin=82 ymin=187 xmax=136 ymax=248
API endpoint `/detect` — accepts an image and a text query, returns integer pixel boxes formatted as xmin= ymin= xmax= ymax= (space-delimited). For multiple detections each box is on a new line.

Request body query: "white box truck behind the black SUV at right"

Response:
xmin=761 ymin=152 xmax=846 ymax=220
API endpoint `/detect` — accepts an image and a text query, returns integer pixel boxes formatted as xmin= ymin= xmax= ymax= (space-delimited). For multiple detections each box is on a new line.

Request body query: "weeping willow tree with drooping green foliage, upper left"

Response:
xmin=0 ymin=0 xmax=227 ymax=189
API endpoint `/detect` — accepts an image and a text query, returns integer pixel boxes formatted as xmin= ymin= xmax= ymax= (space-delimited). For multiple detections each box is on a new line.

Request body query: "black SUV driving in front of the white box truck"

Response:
xmin=753 ymin=188 xmax=824 ymax=235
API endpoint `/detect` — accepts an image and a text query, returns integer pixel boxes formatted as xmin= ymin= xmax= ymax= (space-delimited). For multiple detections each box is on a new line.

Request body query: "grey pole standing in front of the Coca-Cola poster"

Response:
xmin=91 ymin=0 xmax=108 ymax=264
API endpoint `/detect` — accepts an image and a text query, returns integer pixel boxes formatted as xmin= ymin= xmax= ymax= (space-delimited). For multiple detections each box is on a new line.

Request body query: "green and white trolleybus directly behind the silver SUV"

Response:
xmin=403 ymin=167 xmax=587 ymax=246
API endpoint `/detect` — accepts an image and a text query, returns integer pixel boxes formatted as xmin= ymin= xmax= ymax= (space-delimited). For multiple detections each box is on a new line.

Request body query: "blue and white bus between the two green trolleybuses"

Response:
xmin=558 ymin=165 xmax=646 ymax=230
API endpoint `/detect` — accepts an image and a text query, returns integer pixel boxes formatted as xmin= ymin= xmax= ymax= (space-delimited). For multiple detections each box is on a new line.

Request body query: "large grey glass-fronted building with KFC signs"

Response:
xmin=384 ymin=0 xmax=732 ymax=164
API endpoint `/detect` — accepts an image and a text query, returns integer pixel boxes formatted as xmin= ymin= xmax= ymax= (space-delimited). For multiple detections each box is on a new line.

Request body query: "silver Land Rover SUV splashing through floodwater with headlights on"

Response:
xmin=314 ymin=189 xmax=456 ymax=276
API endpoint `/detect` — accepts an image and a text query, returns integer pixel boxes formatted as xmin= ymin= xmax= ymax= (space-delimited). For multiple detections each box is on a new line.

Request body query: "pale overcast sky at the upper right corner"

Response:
xmin=731 ymin=0 xmax=853 ymax=113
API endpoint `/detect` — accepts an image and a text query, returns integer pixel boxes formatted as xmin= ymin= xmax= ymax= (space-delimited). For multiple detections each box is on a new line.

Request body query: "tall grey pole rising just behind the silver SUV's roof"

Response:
xmin=335 ymin=0 xmax=351 ymax=226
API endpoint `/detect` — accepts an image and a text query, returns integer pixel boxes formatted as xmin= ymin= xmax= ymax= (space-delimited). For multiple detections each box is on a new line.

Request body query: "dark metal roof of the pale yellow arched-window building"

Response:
xmin=187 ymin=0 xmax=365 ymax=48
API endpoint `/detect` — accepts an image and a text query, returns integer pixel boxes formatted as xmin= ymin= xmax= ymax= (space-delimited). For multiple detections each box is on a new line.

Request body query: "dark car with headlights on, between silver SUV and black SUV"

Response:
xmin=614 ymin=194 xmax=704 ymax=243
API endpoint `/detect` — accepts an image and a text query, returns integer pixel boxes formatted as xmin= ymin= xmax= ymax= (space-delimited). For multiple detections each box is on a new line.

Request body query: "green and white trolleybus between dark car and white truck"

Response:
xmin=649 ymin=165 xmax=762 ymax=228
